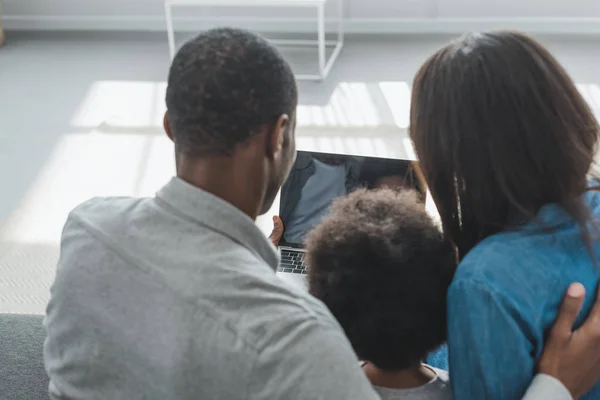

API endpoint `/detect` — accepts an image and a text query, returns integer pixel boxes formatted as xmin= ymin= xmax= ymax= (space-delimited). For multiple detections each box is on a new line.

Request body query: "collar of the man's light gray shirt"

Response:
xmin=156 ymin=177 xmax=279 ymax=270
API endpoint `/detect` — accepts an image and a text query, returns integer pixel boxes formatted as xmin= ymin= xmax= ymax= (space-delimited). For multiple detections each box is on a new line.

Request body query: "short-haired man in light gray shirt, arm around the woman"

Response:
xmin=44 ymin=29 xmax=600 ymax=400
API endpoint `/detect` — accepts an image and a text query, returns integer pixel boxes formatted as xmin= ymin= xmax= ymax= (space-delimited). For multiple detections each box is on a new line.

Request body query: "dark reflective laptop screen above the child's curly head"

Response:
xmin=279 ymin=151 xmax=426 ymax=247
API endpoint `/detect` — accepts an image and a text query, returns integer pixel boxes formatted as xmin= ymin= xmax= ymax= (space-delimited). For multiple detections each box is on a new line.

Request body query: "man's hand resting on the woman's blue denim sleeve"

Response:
xmin=538 ymin=283 xmax=600 ymax=399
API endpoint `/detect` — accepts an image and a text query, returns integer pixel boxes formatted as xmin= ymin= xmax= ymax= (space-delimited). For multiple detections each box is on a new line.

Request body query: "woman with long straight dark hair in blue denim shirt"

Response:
xmin=410 ymin=32 xmax=600 ymax=400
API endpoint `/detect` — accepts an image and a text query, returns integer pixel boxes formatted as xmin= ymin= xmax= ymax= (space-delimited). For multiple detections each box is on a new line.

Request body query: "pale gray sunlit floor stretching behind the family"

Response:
xmin=0 ymin=33 xmax=600 ymax=313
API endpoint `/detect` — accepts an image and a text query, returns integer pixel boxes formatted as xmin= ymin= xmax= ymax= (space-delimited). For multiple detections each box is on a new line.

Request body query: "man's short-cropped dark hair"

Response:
xmin=167 ymin=28 xmax=297 ymax=156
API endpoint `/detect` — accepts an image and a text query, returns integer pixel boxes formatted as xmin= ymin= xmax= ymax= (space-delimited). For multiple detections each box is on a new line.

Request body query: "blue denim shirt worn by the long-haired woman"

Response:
xmin=448 ymin=192 xmax=600 ymax=400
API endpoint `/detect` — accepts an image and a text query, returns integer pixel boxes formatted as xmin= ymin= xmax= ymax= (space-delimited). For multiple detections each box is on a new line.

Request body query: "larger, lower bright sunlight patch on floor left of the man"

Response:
xmin=0 ymin=132 xmax=174 ymax=243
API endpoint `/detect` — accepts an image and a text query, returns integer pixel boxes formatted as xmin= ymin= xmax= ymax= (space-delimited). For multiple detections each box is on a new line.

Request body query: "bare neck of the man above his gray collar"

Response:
xmin=177 ymin=157 xmax=264 ymax=220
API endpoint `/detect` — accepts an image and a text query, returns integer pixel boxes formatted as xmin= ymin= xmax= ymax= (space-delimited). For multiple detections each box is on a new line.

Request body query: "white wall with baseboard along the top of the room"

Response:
xmin=0 ymin=0 xmax=600 ymax=33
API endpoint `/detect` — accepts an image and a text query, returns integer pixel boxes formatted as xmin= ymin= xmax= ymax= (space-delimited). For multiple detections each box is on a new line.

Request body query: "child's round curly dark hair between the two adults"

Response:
xmin=307 ymin=189 xmax=455 ymax=370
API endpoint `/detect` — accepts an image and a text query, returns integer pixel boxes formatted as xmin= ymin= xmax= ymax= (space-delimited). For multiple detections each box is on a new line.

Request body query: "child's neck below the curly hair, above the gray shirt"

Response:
xmin=363 ymin=362 xmax=436 ymax=389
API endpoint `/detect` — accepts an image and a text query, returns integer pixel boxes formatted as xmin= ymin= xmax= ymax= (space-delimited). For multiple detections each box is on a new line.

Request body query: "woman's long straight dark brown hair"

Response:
xmin=410 ymin=31 xmax=599 ymax=258
